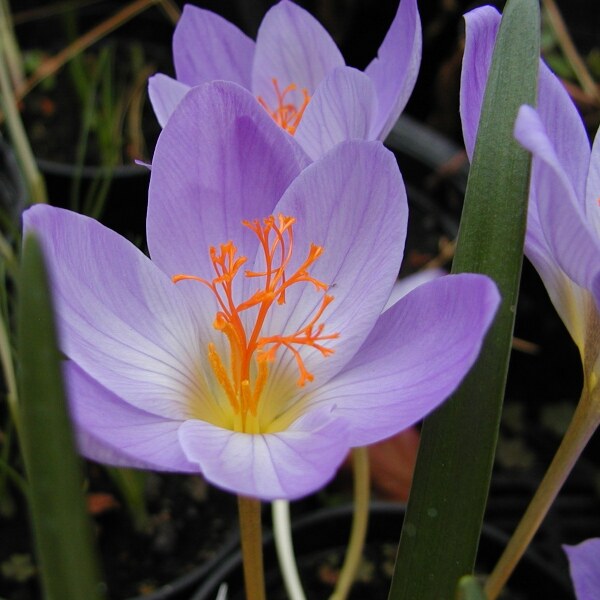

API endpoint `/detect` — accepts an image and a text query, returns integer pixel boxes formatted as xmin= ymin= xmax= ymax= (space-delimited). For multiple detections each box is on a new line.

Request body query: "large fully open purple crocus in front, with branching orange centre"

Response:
xmin=24 ymin=82 xmax=498 ymax=499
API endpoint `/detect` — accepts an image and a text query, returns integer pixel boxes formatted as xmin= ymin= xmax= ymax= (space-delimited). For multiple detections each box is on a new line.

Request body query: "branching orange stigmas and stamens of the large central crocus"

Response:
xmin=171 ymin=215 xmax=339 ymax=433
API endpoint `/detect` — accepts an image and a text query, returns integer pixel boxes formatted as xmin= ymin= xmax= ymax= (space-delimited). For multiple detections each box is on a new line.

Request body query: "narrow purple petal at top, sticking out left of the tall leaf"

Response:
xmin=460 ymin=6 xmax=501 ymax=160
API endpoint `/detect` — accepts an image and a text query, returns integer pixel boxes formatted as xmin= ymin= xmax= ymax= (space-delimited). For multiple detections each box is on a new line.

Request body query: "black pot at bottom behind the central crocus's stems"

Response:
xmin=191 ymin=503 xmax=573 ymax=600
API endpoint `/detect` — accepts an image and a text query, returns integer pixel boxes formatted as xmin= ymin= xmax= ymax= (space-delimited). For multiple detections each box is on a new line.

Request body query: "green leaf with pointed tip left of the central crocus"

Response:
xmin=17 ymin=236 xmax=102 ymax=600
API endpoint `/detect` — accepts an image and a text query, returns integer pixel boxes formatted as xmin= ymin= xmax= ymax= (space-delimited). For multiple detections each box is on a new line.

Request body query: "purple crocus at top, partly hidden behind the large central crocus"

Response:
xmin=149 ymin=0 xmax=421 ymax=159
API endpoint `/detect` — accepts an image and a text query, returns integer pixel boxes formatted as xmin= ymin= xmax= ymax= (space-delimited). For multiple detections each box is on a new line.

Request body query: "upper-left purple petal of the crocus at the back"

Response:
xmin=173 ymin=4 xmax=254 ymax=88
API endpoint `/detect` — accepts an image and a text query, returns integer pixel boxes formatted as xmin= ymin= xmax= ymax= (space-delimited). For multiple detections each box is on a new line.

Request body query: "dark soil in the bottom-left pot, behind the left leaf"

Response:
xmin=0 ymin=464 xmax=237 ymax=600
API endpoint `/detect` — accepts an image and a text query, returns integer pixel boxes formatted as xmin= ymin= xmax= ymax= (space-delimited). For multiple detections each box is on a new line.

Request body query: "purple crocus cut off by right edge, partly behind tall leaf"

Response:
xmin=461 ymin=7 xmax=600 ymax=376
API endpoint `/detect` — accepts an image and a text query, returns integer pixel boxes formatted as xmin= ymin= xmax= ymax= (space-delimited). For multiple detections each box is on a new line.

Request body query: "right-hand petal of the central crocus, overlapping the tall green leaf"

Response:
xmin=311 ymin=274 xmax=499 ymax=446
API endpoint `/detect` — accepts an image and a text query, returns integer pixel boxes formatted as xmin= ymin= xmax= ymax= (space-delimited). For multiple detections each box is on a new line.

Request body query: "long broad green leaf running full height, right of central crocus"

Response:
xmin=390 ymin=0 xmax=539 ymax=600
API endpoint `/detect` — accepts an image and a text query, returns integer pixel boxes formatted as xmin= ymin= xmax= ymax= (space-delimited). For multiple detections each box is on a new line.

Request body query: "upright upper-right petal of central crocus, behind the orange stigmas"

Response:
xmin=266 ymin=141 xmax=408 ymax=381
